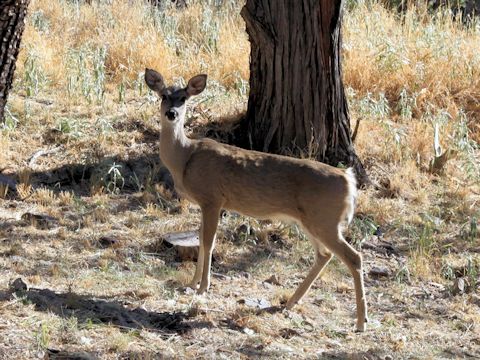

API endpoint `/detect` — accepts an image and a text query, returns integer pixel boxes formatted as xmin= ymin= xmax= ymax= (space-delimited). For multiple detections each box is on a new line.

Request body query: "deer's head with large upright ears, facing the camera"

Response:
xmin=145 ymin=69 xmax=207 ymax=124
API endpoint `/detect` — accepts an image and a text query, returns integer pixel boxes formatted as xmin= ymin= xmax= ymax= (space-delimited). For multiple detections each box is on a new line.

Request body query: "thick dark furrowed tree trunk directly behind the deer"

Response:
xmin=236 ymin=0 xmax=367 ymax=183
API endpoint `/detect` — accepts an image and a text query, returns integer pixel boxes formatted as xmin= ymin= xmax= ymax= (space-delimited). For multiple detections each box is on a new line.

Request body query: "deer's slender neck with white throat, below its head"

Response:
xmin=160 ymin=120 xmax=192 ymax=186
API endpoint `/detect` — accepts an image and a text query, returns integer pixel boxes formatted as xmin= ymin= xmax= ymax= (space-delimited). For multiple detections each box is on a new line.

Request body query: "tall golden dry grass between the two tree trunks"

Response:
xmin=19 ymin=0 xmax=249 ymax=94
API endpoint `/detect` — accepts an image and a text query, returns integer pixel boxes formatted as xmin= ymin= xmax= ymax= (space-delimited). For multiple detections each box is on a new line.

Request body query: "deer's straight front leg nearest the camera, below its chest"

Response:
xmin=194 ymin=205 xmax=220 ymax=294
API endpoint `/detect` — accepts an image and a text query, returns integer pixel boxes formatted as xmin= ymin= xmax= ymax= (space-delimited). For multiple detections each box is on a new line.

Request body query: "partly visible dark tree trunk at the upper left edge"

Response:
xmin=0 ymin=0 xmax=30 ymax=123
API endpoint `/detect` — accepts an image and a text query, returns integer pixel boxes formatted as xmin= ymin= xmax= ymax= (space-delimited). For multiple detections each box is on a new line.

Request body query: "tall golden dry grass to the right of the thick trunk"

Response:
xmin=344 ymin=2 xmax=480 ymax=124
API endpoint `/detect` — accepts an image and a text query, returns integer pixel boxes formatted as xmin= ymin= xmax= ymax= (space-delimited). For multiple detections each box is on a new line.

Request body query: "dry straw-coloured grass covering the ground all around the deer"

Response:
xmin=0 ymin=0 xmax=480 ymax=359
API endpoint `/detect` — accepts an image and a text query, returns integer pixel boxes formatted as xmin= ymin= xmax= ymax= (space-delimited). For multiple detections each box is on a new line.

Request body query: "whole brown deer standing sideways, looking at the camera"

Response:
xmin=145 ymin=69 xmax=367 ymax=331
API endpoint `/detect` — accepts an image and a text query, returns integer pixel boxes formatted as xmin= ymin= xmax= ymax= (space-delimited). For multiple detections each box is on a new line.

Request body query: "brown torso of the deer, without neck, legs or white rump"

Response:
xmin=183 ymin=139 xmax=347 ymax=218
